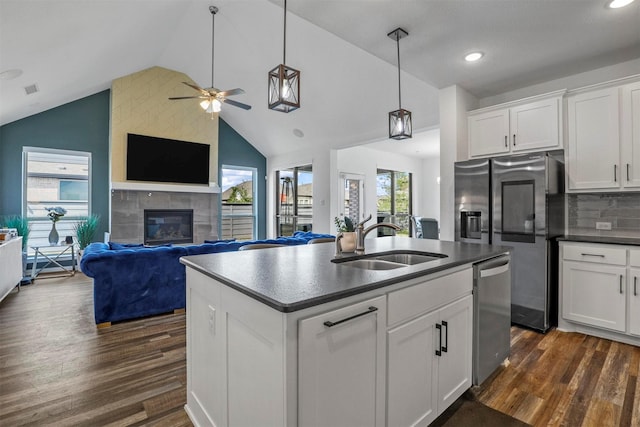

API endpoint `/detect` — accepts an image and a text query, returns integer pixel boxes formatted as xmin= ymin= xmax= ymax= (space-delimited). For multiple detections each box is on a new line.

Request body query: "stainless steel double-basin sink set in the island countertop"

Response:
xmin=331 ymin=250 xmax=447 ymax=270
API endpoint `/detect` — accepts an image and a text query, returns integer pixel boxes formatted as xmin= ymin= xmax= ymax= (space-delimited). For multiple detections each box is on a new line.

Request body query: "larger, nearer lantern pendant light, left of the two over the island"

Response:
xmin=269 ymin=0 xmax=300 ymax=113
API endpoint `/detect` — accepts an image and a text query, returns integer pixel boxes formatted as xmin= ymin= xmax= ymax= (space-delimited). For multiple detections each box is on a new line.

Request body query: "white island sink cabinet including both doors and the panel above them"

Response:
xmin=387 ymin=270 xmax=473 ymax=426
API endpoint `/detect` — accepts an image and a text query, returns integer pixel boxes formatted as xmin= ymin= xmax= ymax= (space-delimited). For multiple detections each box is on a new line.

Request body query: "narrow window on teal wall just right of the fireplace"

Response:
xmin=220 ymin=166 xmax=258 ymax=240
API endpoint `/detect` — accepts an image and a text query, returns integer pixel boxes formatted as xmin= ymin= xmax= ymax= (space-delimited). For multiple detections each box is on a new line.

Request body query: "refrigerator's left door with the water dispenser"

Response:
xmin=454 ymin=159 xmax=491 ymax=243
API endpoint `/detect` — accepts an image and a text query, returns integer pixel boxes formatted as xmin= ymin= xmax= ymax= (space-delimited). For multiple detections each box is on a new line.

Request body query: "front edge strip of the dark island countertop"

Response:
xmin=180 ymin=251 xmax=508 ymax=313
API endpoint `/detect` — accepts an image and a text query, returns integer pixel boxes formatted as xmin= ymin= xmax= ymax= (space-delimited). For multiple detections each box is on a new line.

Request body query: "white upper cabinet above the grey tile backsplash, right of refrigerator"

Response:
xmin=567 ymin=82 xmax=640 ymax=191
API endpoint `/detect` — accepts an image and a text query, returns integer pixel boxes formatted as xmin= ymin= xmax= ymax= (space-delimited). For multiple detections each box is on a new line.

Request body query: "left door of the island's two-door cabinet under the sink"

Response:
xmin=387 ymin=312 xmax=439 ymax=427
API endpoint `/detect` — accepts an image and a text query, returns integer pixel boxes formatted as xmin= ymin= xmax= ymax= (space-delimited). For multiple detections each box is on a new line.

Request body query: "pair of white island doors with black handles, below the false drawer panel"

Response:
xmin=387 ymin=295 xmax=473 ymax=426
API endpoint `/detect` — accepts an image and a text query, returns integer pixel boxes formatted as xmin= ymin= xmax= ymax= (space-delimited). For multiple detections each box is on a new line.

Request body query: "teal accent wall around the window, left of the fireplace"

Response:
xmin=0 ymin=90 xmax=110 ymax=240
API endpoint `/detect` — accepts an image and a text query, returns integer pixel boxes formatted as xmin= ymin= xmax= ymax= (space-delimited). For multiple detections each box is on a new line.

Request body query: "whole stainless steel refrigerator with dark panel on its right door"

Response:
xmin=455 ymin=150 xmax=564 ymax=332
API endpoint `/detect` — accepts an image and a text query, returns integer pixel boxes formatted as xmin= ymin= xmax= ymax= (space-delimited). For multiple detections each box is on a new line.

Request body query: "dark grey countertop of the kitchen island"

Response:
xmin=180 ymin=237 xmax=509 ymax=313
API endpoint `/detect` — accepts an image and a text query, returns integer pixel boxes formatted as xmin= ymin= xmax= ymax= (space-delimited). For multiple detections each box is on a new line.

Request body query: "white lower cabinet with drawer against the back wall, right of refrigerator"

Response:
xmin=559 ymin=242 xmax=640 ymax=345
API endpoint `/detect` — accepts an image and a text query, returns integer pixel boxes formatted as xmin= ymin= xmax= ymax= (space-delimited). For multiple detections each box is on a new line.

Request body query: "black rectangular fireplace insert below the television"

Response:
xmin=144 ymin=209 xmax=193 ymax=245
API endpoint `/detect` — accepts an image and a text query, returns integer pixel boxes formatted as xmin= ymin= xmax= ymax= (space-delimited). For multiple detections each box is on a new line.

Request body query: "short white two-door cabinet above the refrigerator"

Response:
xmin=468 ymin=96 xmax=562 ymax=157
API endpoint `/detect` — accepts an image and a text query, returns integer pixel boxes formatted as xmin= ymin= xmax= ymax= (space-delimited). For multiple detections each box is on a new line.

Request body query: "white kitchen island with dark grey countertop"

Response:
xmin=181 ymin=237 xmax=508 ymax=426
